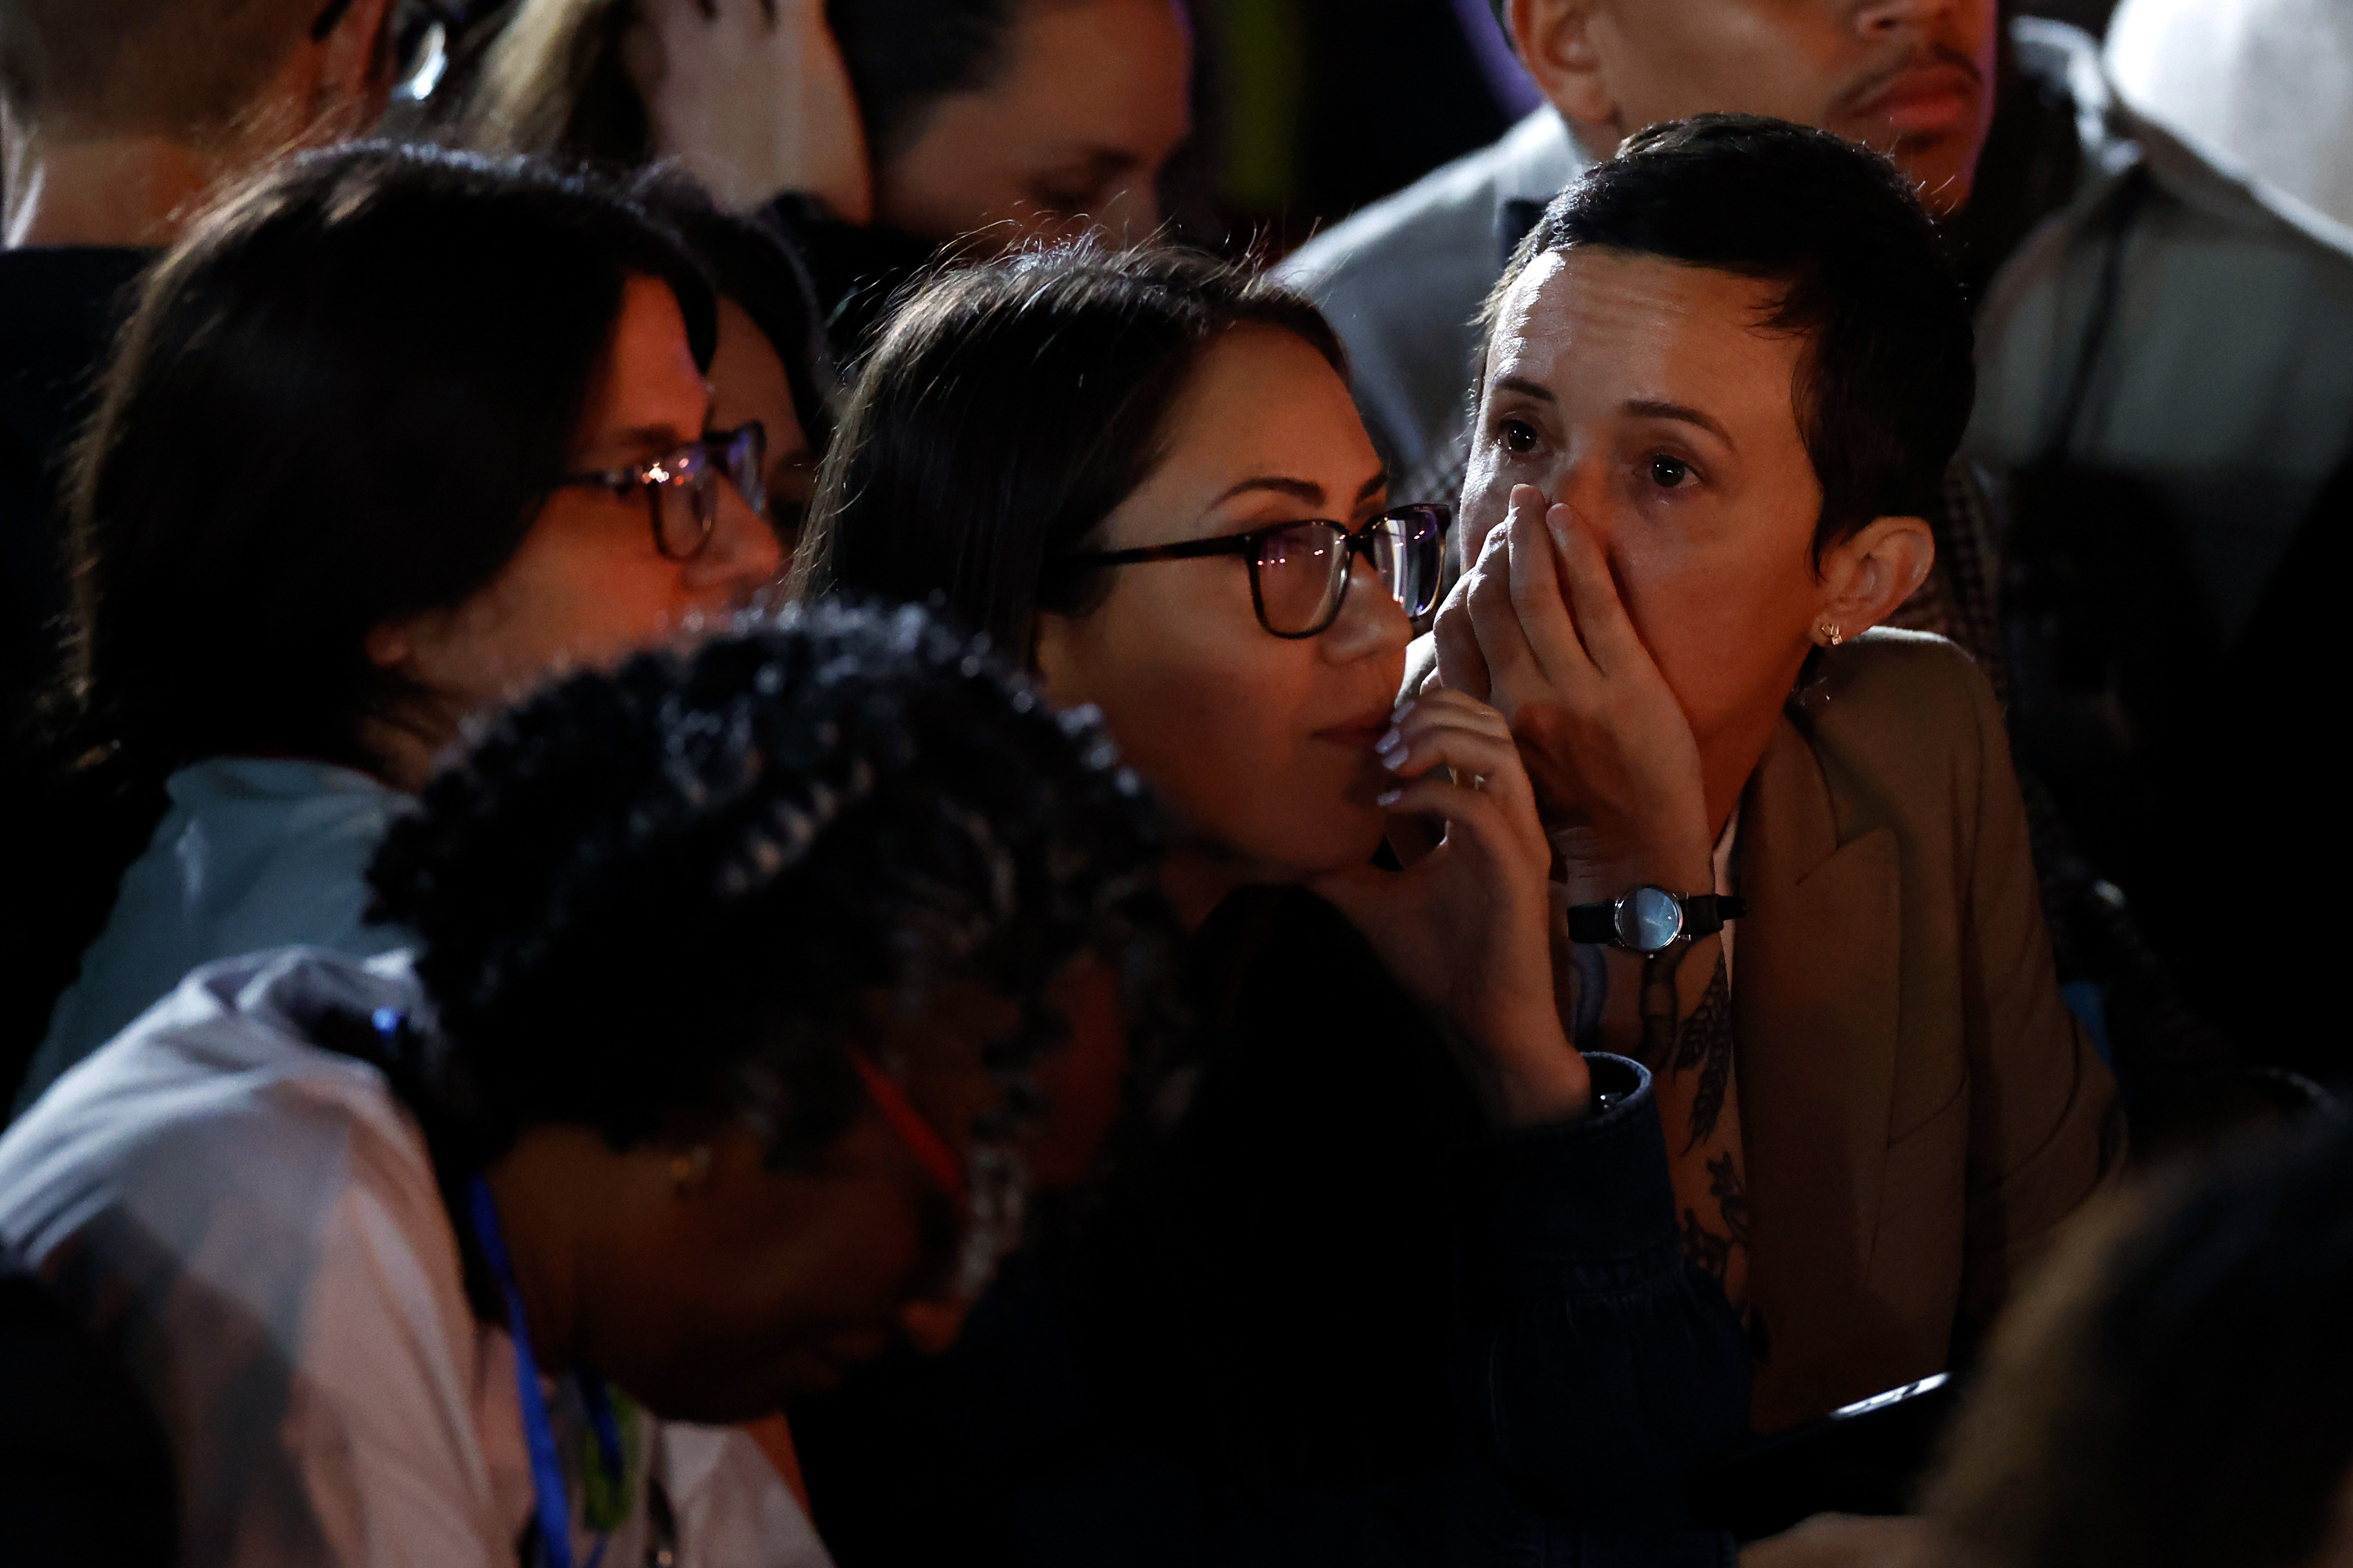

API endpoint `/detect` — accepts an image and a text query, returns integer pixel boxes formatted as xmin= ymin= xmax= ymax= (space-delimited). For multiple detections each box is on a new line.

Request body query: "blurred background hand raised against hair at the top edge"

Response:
xmin=626 ymin=0 xmax=873 ymax=223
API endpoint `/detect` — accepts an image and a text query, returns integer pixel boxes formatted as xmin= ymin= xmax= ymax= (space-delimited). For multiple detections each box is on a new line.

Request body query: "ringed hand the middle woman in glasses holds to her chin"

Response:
xmin=1311 ymin=691 xmax=1593 ymax=1126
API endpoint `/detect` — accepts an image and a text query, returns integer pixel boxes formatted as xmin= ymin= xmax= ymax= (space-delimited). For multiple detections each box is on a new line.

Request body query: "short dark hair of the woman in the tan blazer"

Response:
xmin=1480 ymin=115 xmax=1977 ymax=559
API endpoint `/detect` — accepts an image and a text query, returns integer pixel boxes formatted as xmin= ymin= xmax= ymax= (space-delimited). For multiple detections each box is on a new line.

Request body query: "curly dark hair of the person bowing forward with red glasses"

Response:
xmin=369 ymin=604 xmax=1167 ymax=1166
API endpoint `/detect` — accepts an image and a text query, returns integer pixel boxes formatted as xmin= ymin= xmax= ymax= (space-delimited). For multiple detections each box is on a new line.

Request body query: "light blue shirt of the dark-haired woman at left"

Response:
xmin=16 ymin=757 xmax=410 ymax=1112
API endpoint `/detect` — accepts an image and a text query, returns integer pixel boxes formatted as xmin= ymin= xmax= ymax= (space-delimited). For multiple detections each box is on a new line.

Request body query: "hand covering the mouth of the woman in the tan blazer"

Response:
xmin=1435 ymin=484 xmax=1713 ymax=903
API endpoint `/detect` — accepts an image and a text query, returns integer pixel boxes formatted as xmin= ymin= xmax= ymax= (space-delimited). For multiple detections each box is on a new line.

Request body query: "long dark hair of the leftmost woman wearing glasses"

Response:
xmin=0 ymin=146 xmax=713 ymax=1105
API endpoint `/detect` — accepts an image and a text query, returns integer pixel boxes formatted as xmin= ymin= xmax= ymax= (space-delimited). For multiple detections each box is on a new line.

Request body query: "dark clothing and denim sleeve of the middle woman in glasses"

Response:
xmin=793 ymin=891 xmax=1748 ymax=1568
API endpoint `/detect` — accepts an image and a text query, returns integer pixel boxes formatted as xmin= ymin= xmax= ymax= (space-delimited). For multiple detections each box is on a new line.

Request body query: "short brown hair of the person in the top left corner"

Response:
xmin=0 ymin=0 xmax=322 ymax=141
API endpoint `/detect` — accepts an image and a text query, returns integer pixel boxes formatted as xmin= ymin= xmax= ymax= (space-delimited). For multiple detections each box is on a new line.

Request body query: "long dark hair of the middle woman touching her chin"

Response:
xmin=793 ymin=242 xmax=1346 ymax=661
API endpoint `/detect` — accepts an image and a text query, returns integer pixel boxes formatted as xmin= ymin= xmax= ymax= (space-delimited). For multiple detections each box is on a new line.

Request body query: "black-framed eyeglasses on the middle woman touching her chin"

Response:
xmin=1064 ymin=506 xmax=1454 ymax=637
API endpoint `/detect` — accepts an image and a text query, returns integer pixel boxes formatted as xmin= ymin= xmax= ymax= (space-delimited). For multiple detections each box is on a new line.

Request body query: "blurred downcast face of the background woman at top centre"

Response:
xmin=875 ymin=0 xmax=1193 ymax=247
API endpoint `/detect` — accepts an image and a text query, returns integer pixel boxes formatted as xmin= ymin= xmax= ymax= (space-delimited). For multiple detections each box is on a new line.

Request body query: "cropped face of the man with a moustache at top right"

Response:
xmin=1506 ymin=0 xmax=2000 ymax=214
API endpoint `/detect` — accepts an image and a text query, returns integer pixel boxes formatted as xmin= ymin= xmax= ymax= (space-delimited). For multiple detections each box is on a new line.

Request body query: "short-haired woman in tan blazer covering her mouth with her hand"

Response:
xmin=1417 ymin=115 xmax=2120 ymax=1432
